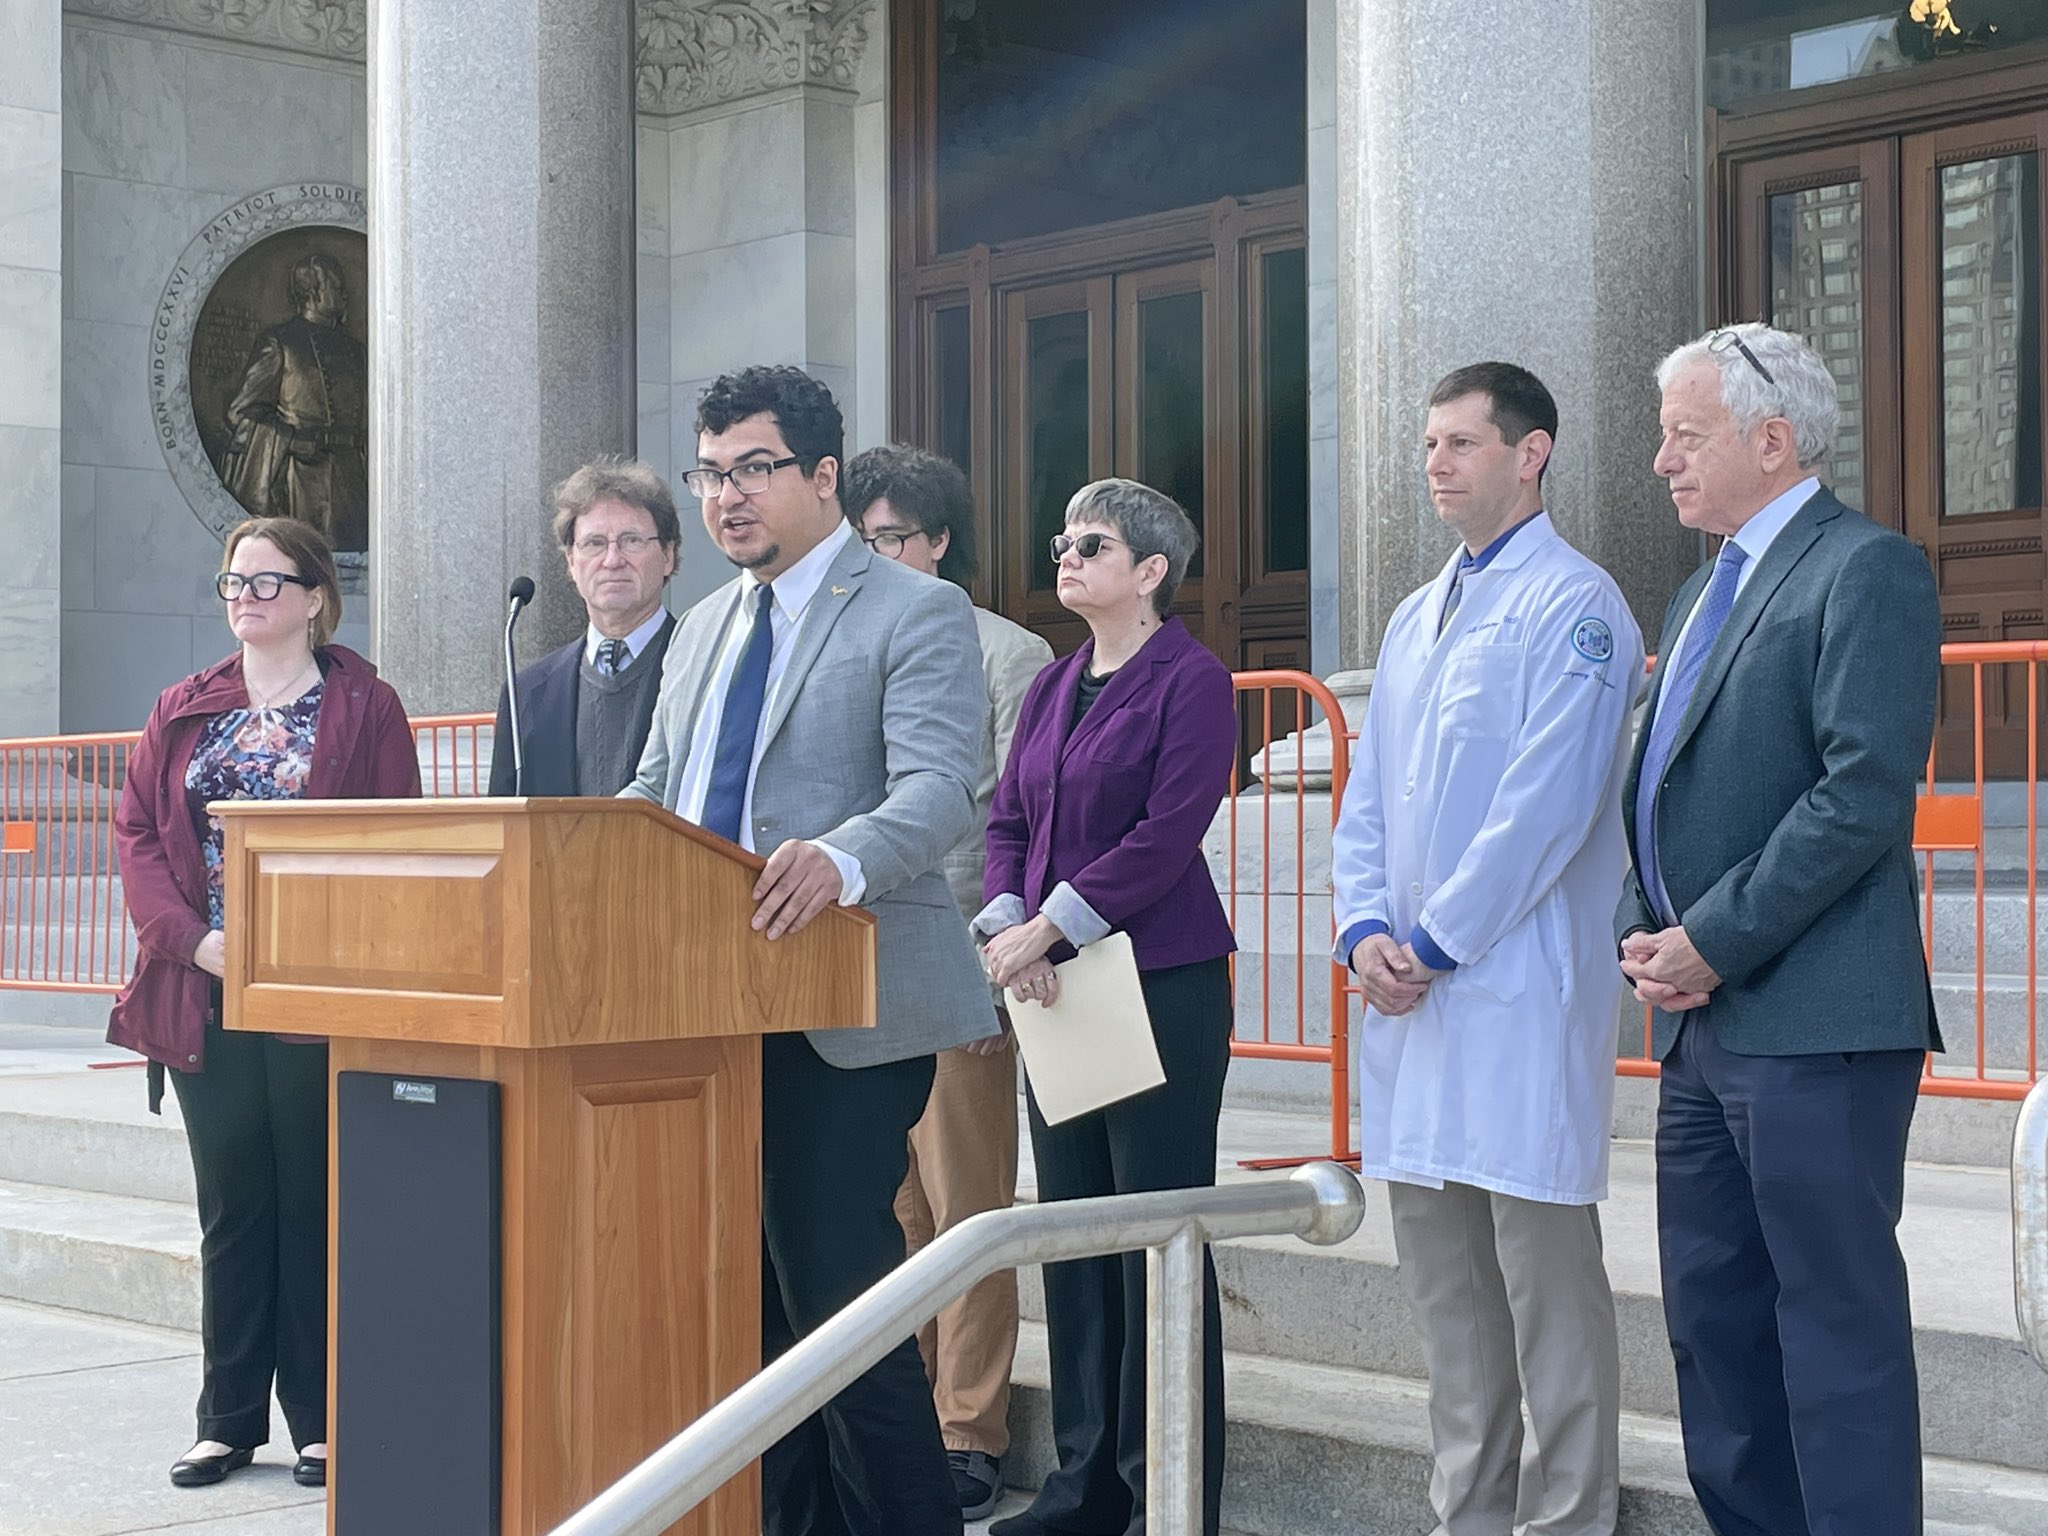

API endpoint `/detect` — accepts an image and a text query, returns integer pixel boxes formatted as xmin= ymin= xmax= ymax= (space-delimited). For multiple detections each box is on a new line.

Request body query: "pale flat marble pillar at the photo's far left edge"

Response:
xmin=0 ymin=0 xmax=63 ymax=737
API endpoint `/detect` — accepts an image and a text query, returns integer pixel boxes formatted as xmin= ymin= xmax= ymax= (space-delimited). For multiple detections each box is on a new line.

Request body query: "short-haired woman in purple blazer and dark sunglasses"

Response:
xmin=975 ymin=479 xmax=1237 ymax=1536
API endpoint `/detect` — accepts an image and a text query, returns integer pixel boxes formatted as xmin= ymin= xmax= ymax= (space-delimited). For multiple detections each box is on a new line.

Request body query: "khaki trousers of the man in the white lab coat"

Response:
xmin=1386 ymin=1184 xmax=1622 ymax=1536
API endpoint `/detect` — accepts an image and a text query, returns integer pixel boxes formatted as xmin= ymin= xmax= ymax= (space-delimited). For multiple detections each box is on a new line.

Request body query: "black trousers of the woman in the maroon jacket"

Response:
xmin=170 ymin=1016 xmax=328 ymax=1448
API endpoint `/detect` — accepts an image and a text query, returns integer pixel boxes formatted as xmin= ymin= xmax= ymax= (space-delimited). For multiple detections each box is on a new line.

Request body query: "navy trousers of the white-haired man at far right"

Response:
xmin=1657 ymin=1020 xmax=1923 ymax=1536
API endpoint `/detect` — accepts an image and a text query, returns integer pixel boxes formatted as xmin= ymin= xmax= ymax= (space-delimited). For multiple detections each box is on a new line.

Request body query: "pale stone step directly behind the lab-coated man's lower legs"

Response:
xmin=1020 ymin=1112 xmax=2048 ymax=1473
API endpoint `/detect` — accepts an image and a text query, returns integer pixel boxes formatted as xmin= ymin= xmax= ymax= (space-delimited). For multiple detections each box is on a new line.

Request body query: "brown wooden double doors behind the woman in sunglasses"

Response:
xmin=897 ymin=190 xmax=1311 ymax=668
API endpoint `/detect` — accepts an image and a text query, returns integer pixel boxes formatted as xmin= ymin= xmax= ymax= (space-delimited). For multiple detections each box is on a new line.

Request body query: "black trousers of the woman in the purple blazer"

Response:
xmin=1026 ymin=961 xmax=1231 ymax=1536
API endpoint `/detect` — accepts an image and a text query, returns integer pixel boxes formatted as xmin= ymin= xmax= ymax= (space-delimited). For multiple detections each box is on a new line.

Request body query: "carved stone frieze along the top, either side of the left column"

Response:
xmin=63 ymin=0 xmax=879 ymax=117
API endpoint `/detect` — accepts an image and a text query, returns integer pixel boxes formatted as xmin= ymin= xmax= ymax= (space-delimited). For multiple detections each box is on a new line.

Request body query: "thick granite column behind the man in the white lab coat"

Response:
xmin=1337 ymin=0 xmax=1704 ymax=668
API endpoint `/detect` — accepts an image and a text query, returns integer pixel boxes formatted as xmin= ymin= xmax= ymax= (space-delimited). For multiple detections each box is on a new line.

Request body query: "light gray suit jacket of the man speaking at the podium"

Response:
xmin=623 ymin=539 xmax=997 ymax=1067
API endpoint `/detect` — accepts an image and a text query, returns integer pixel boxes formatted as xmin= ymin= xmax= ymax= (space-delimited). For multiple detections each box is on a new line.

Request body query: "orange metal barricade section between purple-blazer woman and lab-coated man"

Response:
xmin=1221 ymin=672 xmax=1356 ymax=1167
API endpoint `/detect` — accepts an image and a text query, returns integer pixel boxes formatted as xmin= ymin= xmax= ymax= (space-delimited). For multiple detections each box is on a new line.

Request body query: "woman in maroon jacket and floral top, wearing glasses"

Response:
xmin=106 ymin=518 xmax=420 ymax=1487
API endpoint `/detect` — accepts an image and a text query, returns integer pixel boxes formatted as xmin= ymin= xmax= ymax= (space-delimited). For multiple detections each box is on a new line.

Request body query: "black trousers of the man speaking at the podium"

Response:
xmin=762 ymin=1034 xmax=961 ymax=1536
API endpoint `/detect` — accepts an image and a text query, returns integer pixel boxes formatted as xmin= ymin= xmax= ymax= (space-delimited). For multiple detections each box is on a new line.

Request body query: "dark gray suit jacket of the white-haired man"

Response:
xmin=1616 ymin=489 xmax=1942 ymax=1059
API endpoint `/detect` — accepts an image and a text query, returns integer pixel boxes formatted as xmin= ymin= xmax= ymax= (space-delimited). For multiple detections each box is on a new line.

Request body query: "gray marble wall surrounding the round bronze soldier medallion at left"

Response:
xmin=58 ymin=14 xmax=369 ymax=733
